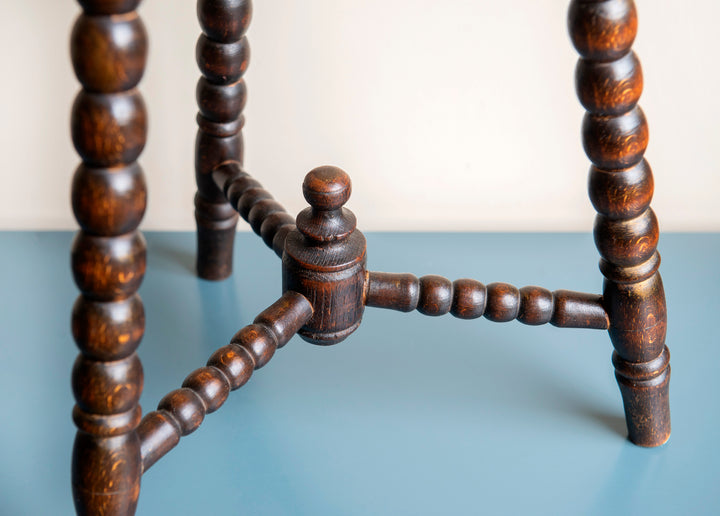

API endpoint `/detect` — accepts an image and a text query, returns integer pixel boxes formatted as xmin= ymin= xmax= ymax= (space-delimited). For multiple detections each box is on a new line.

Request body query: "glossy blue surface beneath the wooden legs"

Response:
xmin=0 ymin=232 xmax=720 ymax=516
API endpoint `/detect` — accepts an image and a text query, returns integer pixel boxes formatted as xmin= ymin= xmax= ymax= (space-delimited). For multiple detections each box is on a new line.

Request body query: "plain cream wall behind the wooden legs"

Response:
xmin=0 ymin=0 xmax=720 ymax=231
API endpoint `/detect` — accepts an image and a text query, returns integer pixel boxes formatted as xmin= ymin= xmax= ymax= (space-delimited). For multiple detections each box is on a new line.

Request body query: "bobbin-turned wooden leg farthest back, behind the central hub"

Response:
xmin=195 ymin=0 xmax=252 ymax=280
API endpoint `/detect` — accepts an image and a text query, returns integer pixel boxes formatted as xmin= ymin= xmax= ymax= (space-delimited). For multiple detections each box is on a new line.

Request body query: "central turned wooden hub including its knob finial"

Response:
xmin=283 ymin=166 xmax=367 ymax=345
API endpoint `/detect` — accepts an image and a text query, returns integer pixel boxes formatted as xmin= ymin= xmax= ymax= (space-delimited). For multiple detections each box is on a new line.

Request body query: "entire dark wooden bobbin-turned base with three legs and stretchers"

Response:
xmin=71 ymin=0 xmax=670 ymax=516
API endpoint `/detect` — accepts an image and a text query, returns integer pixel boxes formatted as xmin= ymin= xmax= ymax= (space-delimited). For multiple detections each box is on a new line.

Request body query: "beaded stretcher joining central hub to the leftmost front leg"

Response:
xmin=138 ymin=291 xmax=313 ymax=471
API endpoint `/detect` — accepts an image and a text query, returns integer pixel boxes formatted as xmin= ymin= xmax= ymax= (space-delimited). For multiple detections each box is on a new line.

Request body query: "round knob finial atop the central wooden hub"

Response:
xmin=297 ymin=166 xmax=357 ymax=242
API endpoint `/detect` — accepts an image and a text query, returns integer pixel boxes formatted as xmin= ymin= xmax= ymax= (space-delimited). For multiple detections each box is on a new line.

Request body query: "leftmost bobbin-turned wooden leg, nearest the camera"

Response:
xmin=70 ymin=0 xmax=147 ymax=516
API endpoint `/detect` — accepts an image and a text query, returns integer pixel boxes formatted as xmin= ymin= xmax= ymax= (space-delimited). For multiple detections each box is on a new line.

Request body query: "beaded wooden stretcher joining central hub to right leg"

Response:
xmin=365 ymin=272 xmax=609 ymax=330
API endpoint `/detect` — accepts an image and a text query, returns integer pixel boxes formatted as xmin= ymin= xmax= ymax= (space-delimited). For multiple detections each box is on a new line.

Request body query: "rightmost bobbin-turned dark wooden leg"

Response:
xmin=568 ymin=0 xmax=670 ymax=446
